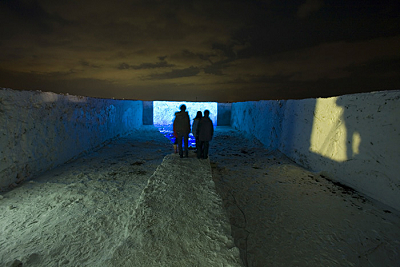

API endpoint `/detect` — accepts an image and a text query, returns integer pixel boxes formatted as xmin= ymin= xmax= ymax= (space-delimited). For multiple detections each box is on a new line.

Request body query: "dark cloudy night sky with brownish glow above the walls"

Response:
xmin=0 ymin=0 xmax=400 ymax=102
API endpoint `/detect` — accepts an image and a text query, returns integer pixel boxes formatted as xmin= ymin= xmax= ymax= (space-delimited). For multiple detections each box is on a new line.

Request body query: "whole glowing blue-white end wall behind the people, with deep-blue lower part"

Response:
xmin=153 ymin=101 xmax=218 ymax=149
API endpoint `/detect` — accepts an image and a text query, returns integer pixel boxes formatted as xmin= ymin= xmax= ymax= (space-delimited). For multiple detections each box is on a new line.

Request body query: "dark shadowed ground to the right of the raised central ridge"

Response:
xmin=210 ymin=127 xmax=400 ymax=266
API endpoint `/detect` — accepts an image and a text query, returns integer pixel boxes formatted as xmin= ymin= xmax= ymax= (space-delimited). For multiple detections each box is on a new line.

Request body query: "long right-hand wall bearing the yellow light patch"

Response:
xmin=231 ymin=91 xmax=400 ymax=213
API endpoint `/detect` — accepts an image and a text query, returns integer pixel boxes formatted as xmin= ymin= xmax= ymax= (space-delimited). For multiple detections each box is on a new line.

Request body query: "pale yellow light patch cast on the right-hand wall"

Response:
xmin=310 ymin=97 xmax=348 ymax=162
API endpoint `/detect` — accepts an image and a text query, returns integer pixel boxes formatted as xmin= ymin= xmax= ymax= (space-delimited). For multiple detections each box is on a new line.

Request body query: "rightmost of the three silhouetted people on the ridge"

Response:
xmin=197 ymin=110 xmax=214 ymax=159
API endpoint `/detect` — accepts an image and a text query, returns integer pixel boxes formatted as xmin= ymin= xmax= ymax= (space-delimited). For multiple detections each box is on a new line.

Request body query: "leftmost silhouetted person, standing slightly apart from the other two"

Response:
xmin=173 ymin=105 xmax=190 ymax=158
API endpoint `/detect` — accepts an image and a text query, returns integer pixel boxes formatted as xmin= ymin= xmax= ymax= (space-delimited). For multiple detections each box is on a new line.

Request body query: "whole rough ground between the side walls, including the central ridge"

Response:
xmin=0 ymin=127 xmax=400 ymax=266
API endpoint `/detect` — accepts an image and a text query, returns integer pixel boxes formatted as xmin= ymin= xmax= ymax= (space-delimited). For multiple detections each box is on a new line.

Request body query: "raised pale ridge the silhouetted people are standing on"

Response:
xmin=110 ymin=153 xmax=242 ymax=266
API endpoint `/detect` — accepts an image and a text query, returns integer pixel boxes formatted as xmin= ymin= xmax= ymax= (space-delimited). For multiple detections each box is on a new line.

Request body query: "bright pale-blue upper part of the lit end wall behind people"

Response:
xmin=153 ymin=101 xmax=218 ymax=126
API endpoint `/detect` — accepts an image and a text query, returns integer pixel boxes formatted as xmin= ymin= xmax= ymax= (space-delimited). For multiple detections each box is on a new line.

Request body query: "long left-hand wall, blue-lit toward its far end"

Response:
xmin=0 ymin=88 xmax=143 ymax=190
